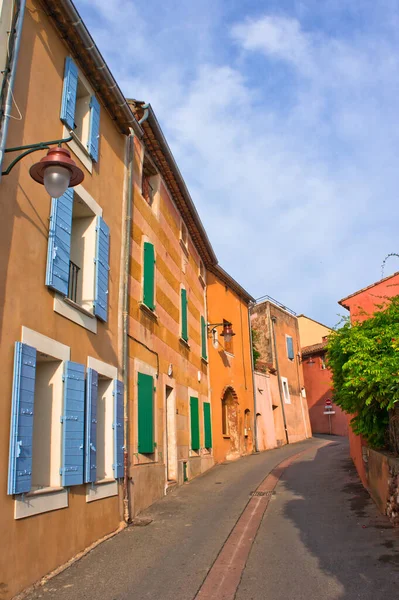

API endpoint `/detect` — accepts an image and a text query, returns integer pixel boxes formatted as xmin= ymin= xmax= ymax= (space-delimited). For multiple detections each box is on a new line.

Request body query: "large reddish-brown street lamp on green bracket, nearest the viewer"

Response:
xmin=2 ymin=137 xmax=84 ymax=198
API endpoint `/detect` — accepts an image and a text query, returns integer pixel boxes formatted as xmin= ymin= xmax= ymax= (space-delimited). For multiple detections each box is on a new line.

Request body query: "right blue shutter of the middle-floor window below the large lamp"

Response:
xmin=94 ymin=217 xmax=109 ymax=321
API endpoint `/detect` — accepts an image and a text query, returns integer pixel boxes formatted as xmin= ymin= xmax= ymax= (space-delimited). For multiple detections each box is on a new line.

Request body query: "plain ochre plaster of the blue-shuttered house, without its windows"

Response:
xmin=0 ymin=0 xmax=125 ymax=598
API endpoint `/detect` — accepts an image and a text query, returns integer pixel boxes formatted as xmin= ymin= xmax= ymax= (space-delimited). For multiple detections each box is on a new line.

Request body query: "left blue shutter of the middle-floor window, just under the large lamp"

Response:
xmin=46 ymin=188 xmax=74 ymax=296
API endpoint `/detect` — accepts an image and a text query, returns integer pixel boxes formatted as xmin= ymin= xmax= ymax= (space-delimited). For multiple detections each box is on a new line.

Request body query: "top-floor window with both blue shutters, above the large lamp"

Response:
xmin=60 ymin=57 xmax=100 ymax=161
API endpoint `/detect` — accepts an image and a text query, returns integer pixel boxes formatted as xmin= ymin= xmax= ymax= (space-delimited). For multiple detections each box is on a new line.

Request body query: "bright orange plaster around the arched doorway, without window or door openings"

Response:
xmin=207 ymin=272 xmax=255 ymax=462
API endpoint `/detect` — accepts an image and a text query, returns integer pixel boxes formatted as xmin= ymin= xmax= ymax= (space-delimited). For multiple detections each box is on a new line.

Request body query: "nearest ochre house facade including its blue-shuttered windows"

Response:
xmin=0 ymin=0 xmax=140 ymax=598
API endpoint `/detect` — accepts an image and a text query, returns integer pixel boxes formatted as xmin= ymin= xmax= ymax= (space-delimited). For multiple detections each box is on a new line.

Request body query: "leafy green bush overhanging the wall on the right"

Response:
xmin=327 ymin=296 xmax=399 ymax=448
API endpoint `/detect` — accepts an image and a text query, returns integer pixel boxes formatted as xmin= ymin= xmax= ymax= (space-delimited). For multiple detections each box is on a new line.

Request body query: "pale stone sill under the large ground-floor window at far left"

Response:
xmin=14 ymin=488 xmax=68 ymax=519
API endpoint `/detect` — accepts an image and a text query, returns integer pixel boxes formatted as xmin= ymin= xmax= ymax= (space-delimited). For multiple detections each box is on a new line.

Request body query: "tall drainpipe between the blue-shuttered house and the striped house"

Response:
xmin=122 ymin=129 xmax=134 ymax=523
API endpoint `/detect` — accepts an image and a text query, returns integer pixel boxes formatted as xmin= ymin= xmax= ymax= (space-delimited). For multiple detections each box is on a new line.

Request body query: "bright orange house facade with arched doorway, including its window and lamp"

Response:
xmin=207 ymin=266 xmax=255 ymax=463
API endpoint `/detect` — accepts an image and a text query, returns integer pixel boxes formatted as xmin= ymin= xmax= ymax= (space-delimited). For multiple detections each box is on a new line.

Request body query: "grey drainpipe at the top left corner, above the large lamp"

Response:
xmin=0 ymin=0 xmax=26 ymax=180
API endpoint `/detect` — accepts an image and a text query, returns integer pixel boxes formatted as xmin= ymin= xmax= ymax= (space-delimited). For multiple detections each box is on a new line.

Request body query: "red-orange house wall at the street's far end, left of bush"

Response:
xmin=302 ymin=352 xmax=348 ymax=435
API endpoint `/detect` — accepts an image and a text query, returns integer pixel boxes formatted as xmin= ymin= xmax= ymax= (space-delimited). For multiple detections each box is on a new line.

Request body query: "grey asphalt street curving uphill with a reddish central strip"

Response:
xmin=28 ymin=437 xmax=399 ymax=600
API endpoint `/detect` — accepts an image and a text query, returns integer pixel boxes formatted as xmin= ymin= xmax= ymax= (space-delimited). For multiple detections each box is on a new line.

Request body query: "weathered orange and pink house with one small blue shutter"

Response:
xmin=251 ymin=301 xmax=312 ymax=445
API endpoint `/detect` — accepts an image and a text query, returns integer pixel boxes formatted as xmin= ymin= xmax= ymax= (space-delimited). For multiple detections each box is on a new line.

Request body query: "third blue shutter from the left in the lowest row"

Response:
xmin=85 ymin=369 xmax=98 ymax=483
